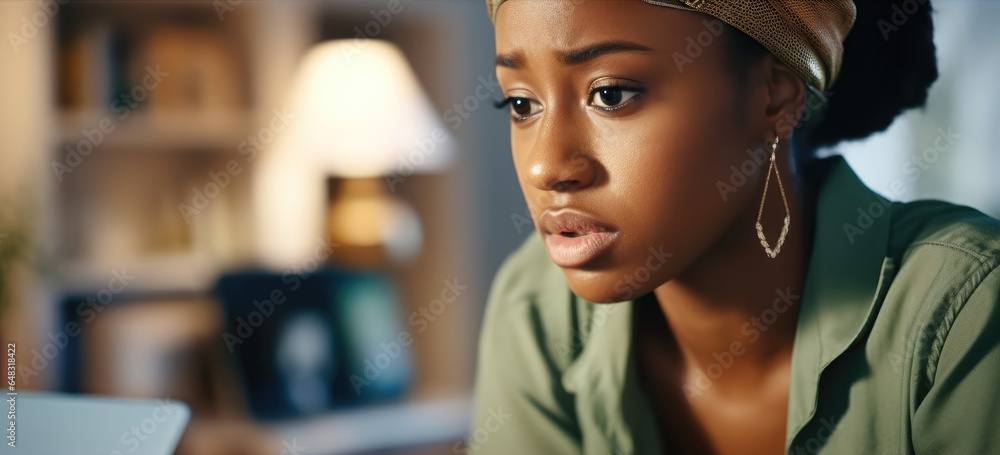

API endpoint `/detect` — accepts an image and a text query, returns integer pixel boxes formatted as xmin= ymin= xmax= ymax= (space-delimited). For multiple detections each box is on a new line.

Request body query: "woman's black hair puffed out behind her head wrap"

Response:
xmin=729 ymin=0 xmax=938 ymax=163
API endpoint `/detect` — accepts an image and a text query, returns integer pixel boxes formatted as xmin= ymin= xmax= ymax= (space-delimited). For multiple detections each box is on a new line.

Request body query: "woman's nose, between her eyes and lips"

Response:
xmin=526 ymin=116 xmax=597 ymax=192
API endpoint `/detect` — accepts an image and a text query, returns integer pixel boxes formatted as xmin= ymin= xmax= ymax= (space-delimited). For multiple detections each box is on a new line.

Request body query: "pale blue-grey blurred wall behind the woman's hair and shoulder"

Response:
xmin=833 ymin=0 xmax=1000 ymax=217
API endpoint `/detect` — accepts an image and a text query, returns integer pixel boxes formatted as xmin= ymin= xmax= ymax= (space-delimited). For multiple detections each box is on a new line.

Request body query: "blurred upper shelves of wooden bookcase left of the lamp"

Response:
xmin=50 ymin=2 xmax=258 ymax=292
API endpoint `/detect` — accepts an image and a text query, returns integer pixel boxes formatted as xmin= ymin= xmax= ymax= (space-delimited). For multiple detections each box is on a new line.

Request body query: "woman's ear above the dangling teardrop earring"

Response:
xmin=761 ymin=56 xmax=806 ymax=140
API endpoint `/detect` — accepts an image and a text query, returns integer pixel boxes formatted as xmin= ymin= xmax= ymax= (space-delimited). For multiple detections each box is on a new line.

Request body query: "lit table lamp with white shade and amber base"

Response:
xmin=289 ymin=40 xmax=455 ymax=267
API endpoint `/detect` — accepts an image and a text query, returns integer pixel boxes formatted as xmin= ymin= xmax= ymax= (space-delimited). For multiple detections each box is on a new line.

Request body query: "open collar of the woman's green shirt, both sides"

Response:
xmin=563 ymin=156 xmax=893 ymax=453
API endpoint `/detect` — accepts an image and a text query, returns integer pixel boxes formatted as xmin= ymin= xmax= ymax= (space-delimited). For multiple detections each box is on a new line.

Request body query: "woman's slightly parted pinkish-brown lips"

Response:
xmin=539 ymin=209 xmax=618 ymax=268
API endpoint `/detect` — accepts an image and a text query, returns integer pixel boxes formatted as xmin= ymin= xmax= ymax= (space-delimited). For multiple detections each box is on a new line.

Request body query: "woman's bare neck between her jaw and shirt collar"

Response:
xmin=653 ymin=151 xmax=813 ymax=391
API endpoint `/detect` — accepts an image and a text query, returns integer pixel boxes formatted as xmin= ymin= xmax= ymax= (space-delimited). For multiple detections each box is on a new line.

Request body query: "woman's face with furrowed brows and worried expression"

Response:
xmin=496 ymin=0 xmax=773 ymax=302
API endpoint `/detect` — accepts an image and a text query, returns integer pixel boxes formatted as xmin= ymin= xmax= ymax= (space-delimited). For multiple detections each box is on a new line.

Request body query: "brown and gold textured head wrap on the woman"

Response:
xmin=486 ymin=0 xmax=857 ymax=97
